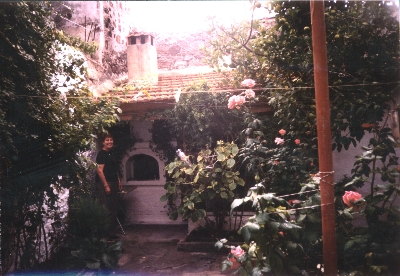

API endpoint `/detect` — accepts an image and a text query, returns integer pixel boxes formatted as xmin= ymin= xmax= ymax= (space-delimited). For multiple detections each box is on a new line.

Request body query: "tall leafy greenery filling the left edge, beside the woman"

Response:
xmin=0 ymin=2 xmax=119 ymax=271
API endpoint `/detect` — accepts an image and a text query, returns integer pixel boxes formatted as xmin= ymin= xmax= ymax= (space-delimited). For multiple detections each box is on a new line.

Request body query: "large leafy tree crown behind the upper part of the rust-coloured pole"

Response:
xmin=208 ymin=1 xmax=399 ymax=151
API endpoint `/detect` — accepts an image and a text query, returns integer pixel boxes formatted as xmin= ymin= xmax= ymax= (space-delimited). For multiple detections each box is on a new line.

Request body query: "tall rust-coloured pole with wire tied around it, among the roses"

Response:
xmin=310 ymin=0 xmax=337 ymax=276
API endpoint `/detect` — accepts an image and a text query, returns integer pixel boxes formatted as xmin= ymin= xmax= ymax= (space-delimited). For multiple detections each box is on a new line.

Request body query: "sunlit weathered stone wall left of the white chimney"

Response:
xmin=56 ymin=1 xmax=132 ymax=71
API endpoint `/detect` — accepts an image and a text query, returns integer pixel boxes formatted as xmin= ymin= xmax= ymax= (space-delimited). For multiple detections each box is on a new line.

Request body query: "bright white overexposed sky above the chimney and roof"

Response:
xmin=126 ymin=1 xmax=274 ymax=33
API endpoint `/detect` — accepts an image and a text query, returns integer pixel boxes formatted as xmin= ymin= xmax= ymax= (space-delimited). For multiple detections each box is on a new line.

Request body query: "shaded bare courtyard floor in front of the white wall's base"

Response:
xmin=114 ymin=225 xmax=233 ymax=276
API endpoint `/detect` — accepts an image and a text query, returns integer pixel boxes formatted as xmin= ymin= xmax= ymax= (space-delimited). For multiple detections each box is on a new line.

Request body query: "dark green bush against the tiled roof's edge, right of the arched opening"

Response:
xmin=149 ymin=81 xmax=244 ymax=154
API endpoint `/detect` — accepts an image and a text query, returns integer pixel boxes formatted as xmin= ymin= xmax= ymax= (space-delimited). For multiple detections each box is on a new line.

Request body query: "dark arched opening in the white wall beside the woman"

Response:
xmin=126 ymin=154 xmax=160 ymax=181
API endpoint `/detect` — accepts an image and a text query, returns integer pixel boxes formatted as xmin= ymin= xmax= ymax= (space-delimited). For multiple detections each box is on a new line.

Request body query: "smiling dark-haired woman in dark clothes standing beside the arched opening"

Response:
xmin=96 ymin=134 xmax=122 ymax=237
